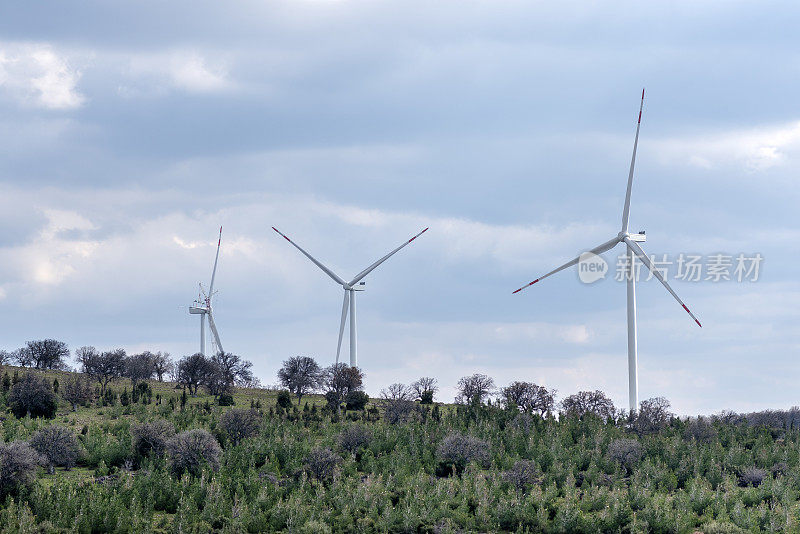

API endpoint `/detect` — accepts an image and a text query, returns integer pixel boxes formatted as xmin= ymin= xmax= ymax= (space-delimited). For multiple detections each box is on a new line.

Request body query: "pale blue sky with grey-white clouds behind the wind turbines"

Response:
xmin=0 ymin=0 xmax=800 ymax=414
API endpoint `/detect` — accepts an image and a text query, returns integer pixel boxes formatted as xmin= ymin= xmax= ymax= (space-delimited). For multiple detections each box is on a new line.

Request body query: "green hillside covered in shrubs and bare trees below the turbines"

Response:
xmin=0 ymin=346 xmax=800 ymax=533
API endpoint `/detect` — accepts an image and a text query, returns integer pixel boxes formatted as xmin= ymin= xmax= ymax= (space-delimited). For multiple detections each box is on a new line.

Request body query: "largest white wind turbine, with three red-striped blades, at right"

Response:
xmin=514 ymin=89 xmax=703 ymax=412
